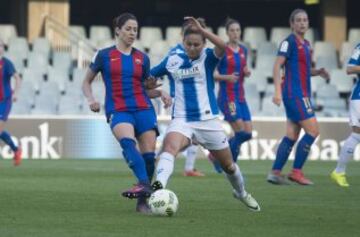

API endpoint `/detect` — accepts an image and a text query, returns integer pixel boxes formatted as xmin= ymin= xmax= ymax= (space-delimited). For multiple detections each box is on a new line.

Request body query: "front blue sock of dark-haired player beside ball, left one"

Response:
xmin=119 ymin=138 xmax=150 ymax=184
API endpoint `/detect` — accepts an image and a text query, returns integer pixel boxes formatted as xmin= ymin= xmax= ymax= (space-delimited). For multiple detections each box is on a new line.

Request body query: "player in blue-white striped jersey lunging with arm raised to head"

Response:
xmin=151 ymin=17 xmax=260 ymax=211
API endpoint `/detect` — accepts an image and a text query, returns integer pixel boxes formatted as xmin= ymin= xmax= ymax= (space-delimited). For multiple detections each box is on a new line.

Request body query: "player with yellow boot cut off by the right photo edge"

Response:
xmin=331 ymin=44 xmax=360 ymax=187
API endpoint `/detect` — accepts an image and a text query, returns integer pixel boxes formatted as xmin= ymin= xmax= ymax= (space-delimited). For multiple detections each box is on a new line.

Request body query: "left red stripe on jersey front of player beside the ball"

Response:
xmin=109 ymin=49 xmax=126 ymax=111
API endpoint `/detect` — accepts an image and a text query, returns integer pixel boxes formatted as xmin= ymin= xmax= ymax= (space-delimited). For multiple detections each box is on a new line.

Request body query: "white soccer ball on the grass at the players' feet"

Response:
xmin=149 ymin=189 xmax=179 ymax=216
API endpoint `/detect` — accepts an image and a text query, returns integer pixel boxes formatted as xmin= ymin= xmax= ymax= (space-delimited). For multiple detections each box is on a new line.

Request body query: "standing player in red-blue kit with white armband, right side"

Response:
xmin=267 ymin=9 xmax=329 ymax=185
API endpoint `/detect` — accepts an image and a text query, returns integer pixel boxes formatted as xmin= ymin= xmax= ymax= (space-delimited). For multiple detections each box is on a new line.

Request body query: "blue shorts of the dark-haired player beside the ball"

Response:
xmin=107 ymin=108 xmax=159 ymax=136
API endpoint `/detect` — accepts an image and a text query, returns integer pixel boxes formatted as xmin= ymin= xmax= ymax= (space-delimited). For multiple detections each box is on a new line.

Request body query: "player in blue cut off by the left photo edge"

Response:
xmin=0 ymin=39 xmax=21 ymax=166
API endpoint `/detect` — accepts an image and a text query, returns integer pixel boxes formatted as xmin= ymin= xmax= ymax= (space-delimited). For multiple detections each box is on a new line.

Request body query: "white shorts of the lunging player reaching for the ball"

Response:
xmin=166 ymin=118 xmax=229 ymax=150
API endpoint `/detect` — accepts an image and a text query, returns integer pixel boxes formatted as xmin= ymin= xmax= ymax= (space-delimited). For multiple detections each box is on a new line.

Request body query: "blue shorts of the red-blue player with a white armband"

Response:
xmin=283 ymin=97 xmax=315 ymax=122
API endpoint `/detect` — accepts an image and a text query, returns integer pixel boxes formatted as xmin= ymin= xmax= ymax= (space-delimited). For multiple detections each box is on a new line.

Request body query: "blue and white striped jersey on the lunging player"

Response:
xmin=150 ymin=48 xmax=219 ymax=121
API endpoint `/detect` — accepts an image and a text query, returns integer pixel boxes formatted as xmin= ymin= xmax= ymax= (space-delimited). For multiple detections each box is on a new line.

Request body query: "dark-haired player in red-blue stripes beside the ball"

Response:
xmin=83 ymin=13 xmax=171 ymax=212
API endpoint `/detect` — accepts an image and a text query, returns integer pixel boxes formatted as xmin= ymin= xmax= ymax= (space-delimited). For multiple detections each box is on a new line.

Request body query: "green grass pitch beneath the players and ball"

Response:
xmin=0 ymin=159 xmax=360 ymax=237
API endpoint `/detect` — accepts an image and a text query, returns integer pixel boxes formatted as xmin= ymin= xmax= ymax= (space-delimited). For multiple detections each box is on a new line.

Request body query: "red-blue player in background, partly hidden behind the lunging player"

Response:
xmin=215 ymin=18 xmax=252 ymax=162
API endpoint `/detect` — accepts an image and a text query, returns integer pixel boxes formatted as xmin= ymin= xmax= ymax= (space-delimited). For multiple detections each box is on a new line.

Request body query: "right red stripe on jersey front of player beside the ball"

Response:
xmin=132 ymin=50 xmax=149 ymax=108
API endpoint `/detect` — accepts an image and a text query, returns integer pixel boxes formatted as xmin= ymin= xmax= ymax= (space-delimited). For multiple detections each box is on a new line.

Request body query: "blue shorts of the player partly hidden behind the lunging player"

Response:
xmin=218 ymin=100 xmax=251 ymax=122
